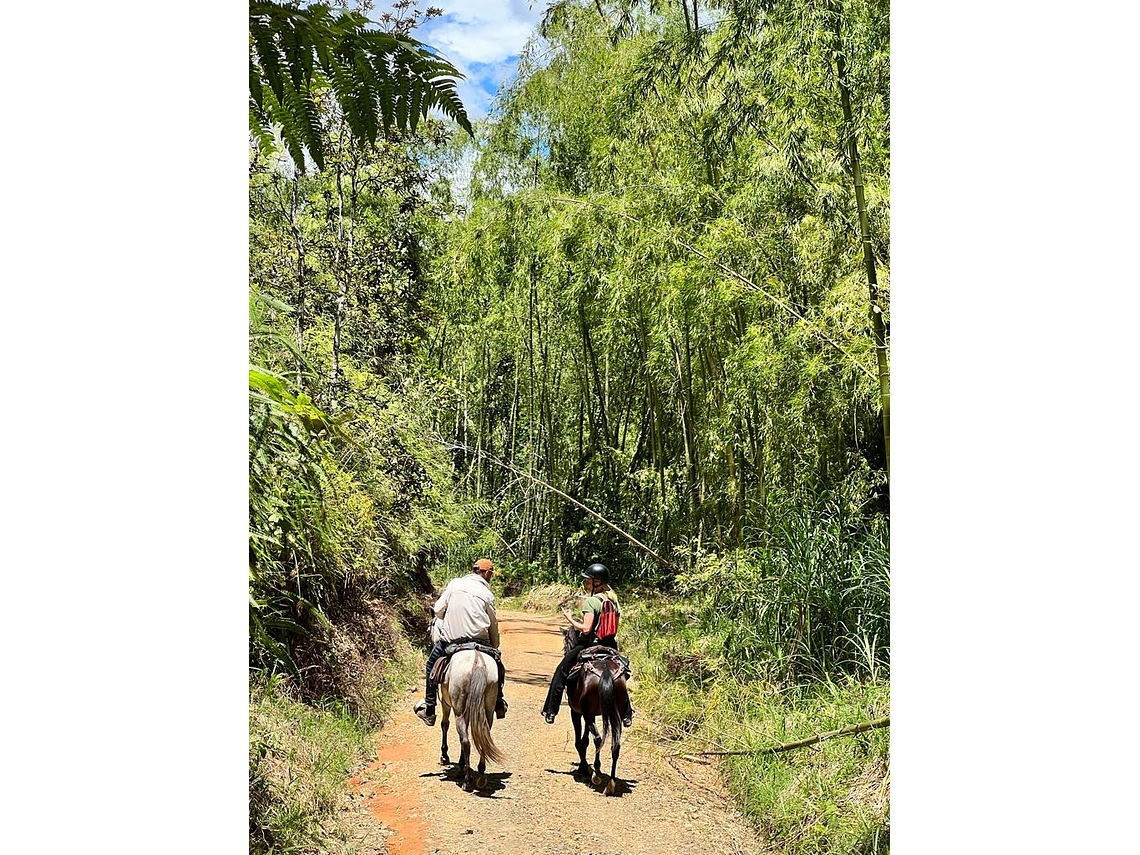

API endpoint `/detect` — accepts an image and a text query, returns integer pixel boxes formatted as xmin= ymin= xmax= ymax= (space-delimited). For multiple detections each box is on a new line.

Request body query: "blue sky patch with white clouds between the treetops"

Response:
xmin=405 ymin=0 xmax=548 ymax=121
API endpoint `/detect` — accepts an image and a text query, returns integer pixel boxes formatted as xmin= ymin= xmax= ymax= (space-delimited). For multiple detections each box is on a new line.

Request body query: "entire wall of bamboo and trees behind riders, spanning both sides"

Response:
xmin=250 ymin=0 xmax=890 ymax=688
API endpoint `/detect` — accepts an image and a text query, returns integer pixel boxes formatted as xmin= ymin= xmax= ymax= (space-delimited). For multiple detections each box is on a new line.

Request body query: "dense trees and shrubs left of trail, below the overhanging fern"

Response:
xmin=250 ymin=108 xmax=467 ymax=684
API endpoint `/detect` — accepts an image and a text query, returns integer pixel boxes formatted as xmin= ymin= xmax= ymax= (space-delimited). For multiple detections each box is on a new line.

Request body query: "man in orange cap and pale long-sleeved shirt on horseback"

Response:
xmin=413 ymin=559 xmax=506 ymax=727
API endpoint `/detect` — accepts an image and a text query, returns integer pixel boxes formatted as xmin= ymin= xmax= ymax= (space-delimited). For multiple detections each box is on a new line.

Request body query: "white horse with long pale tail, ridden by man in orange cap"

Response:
xmin=439 ymin=650 xmax=504 ymax=792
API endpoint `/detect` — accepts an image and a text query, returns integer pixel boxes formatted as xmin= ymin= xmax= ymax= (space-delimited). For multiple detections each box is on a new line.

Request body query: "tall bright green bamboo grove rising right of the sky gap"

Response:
xmin=426 ymin=0 xmax=890 ymax=588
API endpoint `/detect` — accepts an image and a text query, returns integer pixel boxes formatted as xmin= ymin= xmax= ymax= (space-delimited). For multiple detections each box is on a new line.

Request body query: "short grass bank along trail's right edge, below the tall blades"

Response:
xmin=504 ymin=585 xmax=890 ymax=855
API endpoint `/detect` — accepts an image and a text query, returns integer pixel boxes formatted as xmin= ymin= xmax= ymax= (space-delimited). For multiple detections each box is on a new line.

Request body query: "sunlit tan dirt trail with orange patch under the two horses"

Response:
xmin=351 ymin=611 xmax=760 ymax=855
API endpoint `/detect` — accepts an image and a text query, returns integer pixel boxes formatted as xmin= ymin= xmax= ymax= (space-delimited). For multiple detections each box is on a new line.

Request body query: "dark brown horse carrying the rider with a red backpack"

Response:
xmin=562 ymin=627 xmax=629 ymax=796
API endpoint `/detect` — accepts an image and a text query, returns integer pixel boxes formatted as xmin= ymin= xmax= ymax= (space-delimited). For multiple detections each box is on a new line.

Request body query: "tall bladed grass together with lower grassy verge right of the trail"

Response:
xmin=622 ymin=503 xmax=890 ymax=855
